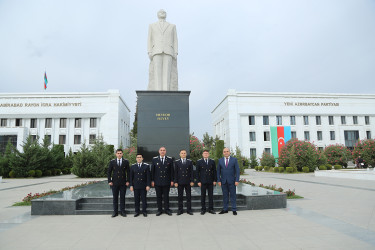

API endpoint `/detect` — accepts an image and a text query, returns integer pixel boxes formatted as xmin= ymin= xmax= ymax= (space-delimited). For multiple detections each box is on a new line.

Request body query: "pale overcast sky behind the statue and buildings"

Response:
xmin=0 ymin=0 xmax=375 ymax=138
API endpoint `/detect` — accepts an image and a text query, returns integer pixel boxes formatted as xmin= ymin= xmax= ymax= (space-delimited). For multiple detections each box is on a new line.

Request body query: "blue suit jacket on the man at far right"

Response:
xmin=217 ymin=157 xmax=240 ymax=184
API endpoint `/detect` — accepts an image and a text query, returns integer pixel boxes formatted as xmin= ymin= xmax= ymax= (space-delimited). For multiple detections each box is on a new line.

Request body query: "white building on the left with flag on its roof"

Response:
xmin=0 ymin=90 xmax=130 ymax=153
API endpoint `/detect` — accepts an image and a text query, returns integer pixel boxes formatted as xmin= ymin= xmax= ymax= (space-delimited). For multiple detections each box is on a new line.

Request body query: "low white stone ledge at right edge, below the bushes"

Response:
xmin=314 ymin=169 xmax=375 ymax=181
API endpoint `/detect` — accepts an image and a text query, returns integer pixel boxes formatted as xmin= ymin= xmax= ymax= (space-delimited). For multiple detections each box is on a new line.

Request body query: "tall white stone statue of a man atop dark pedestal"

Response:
xmin=147 ymin=10 xmax=178 ymax=91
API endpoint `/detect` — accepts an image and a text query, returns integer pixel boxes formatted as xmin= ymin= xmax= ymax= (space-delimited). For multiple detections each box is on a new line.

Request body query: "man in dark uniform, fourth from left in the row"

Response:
xmin=174 ymin=149 xmax=194 ymax=215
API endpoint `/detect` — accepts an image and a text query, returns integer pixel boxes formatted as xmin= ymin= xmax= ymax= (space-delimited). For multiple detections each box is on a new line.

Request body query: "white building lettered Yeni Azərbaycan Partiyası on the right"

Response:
xmin=211 ymin=89 xmax=375 ymax=158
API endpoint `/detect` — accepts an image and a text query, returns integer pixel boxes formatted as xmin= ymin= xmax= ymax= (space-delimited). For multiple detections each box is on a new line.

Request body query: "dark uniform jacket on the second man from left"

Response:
xmin=130 ymin=163 xmax=151 ymax=189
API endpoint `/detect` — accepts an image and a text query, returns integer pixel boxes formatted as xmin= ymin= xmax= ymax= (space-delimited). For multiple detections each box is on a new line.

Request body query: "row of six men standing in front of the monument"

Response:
xmin=108 ymin=147 xmax=239 ymax=217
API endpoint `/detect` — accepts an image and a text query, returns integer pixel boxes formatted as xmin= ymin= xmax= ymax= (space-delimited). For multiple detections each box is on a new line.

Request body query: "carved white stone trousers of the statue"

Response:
xmin=152 ymin=53 xmax=172 ymax=90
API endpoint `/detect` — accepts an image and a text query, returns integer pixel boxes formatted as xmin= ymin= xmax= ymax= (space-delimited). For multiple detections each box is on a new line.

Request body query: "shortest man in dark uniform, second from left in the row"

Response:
xmin=130 ymin=154 xmax=151 ymax=217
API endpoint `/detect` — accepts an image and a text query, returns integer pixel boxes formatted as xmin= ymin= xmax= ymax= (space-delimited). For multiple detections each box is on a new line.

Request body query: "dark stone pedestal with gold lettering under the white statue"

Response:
xmin=136 ymin=91 xmax=190 ymax=163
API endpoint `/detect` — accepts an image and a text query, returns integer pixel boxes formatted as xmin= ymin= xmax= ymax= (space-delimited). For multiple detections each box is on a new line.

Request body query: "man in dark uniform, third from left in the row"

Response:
xmin=151 ymin=147 xmax=174 ymax=216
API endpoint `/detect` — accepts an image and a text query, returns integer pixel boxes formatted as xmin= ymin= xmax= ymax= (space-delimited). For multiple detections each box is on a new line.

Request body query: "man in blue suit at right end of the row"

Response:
xmin=217 ymin=148 xmax=240 ymax=215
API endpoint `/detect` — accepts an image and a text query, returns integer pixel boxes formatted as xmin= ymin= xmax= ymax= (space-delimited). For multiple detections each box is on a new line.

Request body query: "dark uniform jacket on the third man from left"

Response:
xmin=151 ymin=156 xmax=174 ymax=186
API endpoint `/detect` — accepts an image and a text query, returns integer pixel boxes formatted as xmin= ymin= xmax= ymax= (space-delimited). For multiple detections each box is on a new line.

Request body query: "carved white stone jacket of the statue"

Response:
xmin=147 ymin=22 xmax=178 ymax=56
